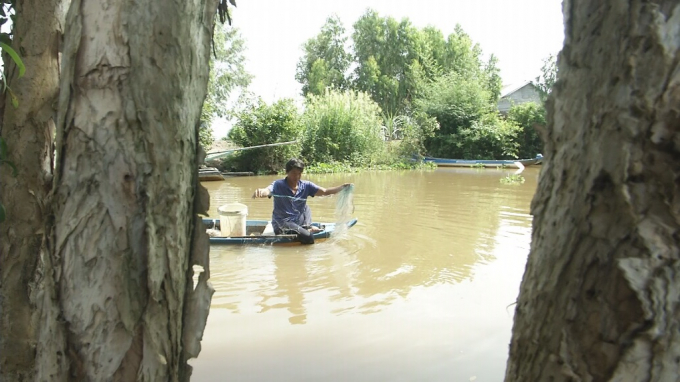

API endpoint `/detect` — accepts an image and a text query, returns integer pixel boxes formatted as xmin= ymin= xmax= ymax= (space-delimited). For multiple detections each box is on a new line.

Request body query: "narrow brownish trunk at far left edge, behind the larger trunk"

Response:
xmin=0 ymin=0 xmax=64 ymax=381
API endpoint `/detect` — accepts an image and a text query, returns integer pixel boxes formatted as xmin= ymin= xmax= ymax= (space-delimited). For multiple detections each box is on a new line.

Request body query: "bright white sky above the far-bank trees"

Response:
xmin=213 ymin=0 xmax=564 ymax=137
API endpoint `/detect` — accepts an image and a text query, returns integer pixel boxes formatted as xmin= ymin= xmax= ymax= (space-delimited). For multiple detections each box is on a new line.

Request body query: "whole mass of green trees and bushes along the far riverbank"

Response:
xmin=210 ymin=10 xmax=555 ymax=173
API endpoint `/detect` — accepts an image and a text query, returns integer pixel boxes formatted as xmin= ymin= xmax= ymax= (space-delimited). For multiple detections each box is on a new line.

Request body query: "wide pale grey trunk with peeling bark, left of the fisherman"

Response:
xmin=37 ymin=0 xmax=217 ymax=381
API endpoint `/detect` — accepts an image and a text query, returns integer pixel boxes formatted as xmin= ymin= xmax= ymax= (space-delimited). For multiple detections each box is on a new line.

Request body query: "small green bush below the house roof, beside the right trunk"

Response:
xmin=508 ymin=102 xmax=546 ymax=158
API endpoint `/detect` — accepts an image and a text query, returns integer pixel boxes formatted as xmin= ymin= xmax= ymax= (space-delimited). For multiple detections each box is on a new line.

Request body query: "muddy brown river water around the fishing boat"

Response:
xmin=190 ymin=168 xmax=538 ymax=382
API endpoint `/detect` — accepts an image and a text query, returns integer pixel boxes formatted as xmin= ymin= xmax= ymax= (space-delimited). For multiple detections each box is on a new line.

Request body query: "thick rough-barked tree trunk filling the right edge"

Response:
xmin=506 ymin=0 xmax=680 ymax=381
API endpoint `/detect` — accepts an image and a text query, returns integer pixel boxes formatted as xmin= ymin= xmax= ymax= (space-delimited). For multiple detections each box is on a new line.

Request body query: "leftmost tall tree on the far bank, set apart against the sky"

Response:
xmin=295 ymin=15 xmax=352 ymax=96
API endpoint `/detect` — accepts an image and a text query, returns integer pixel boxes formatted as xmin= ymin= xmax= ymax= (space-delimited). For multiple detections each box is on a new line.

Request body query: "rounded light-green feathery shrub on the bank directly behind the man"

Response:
xmin=302 ymin=90 xmax=385 ymax=165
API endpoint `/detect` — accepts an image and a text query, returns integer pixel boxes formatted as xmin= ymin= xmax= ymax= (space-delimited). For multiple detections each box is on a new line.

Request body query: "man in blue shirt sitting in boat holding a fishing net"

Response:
xmin=253 ymin=158 xmax=350 ymax=244
